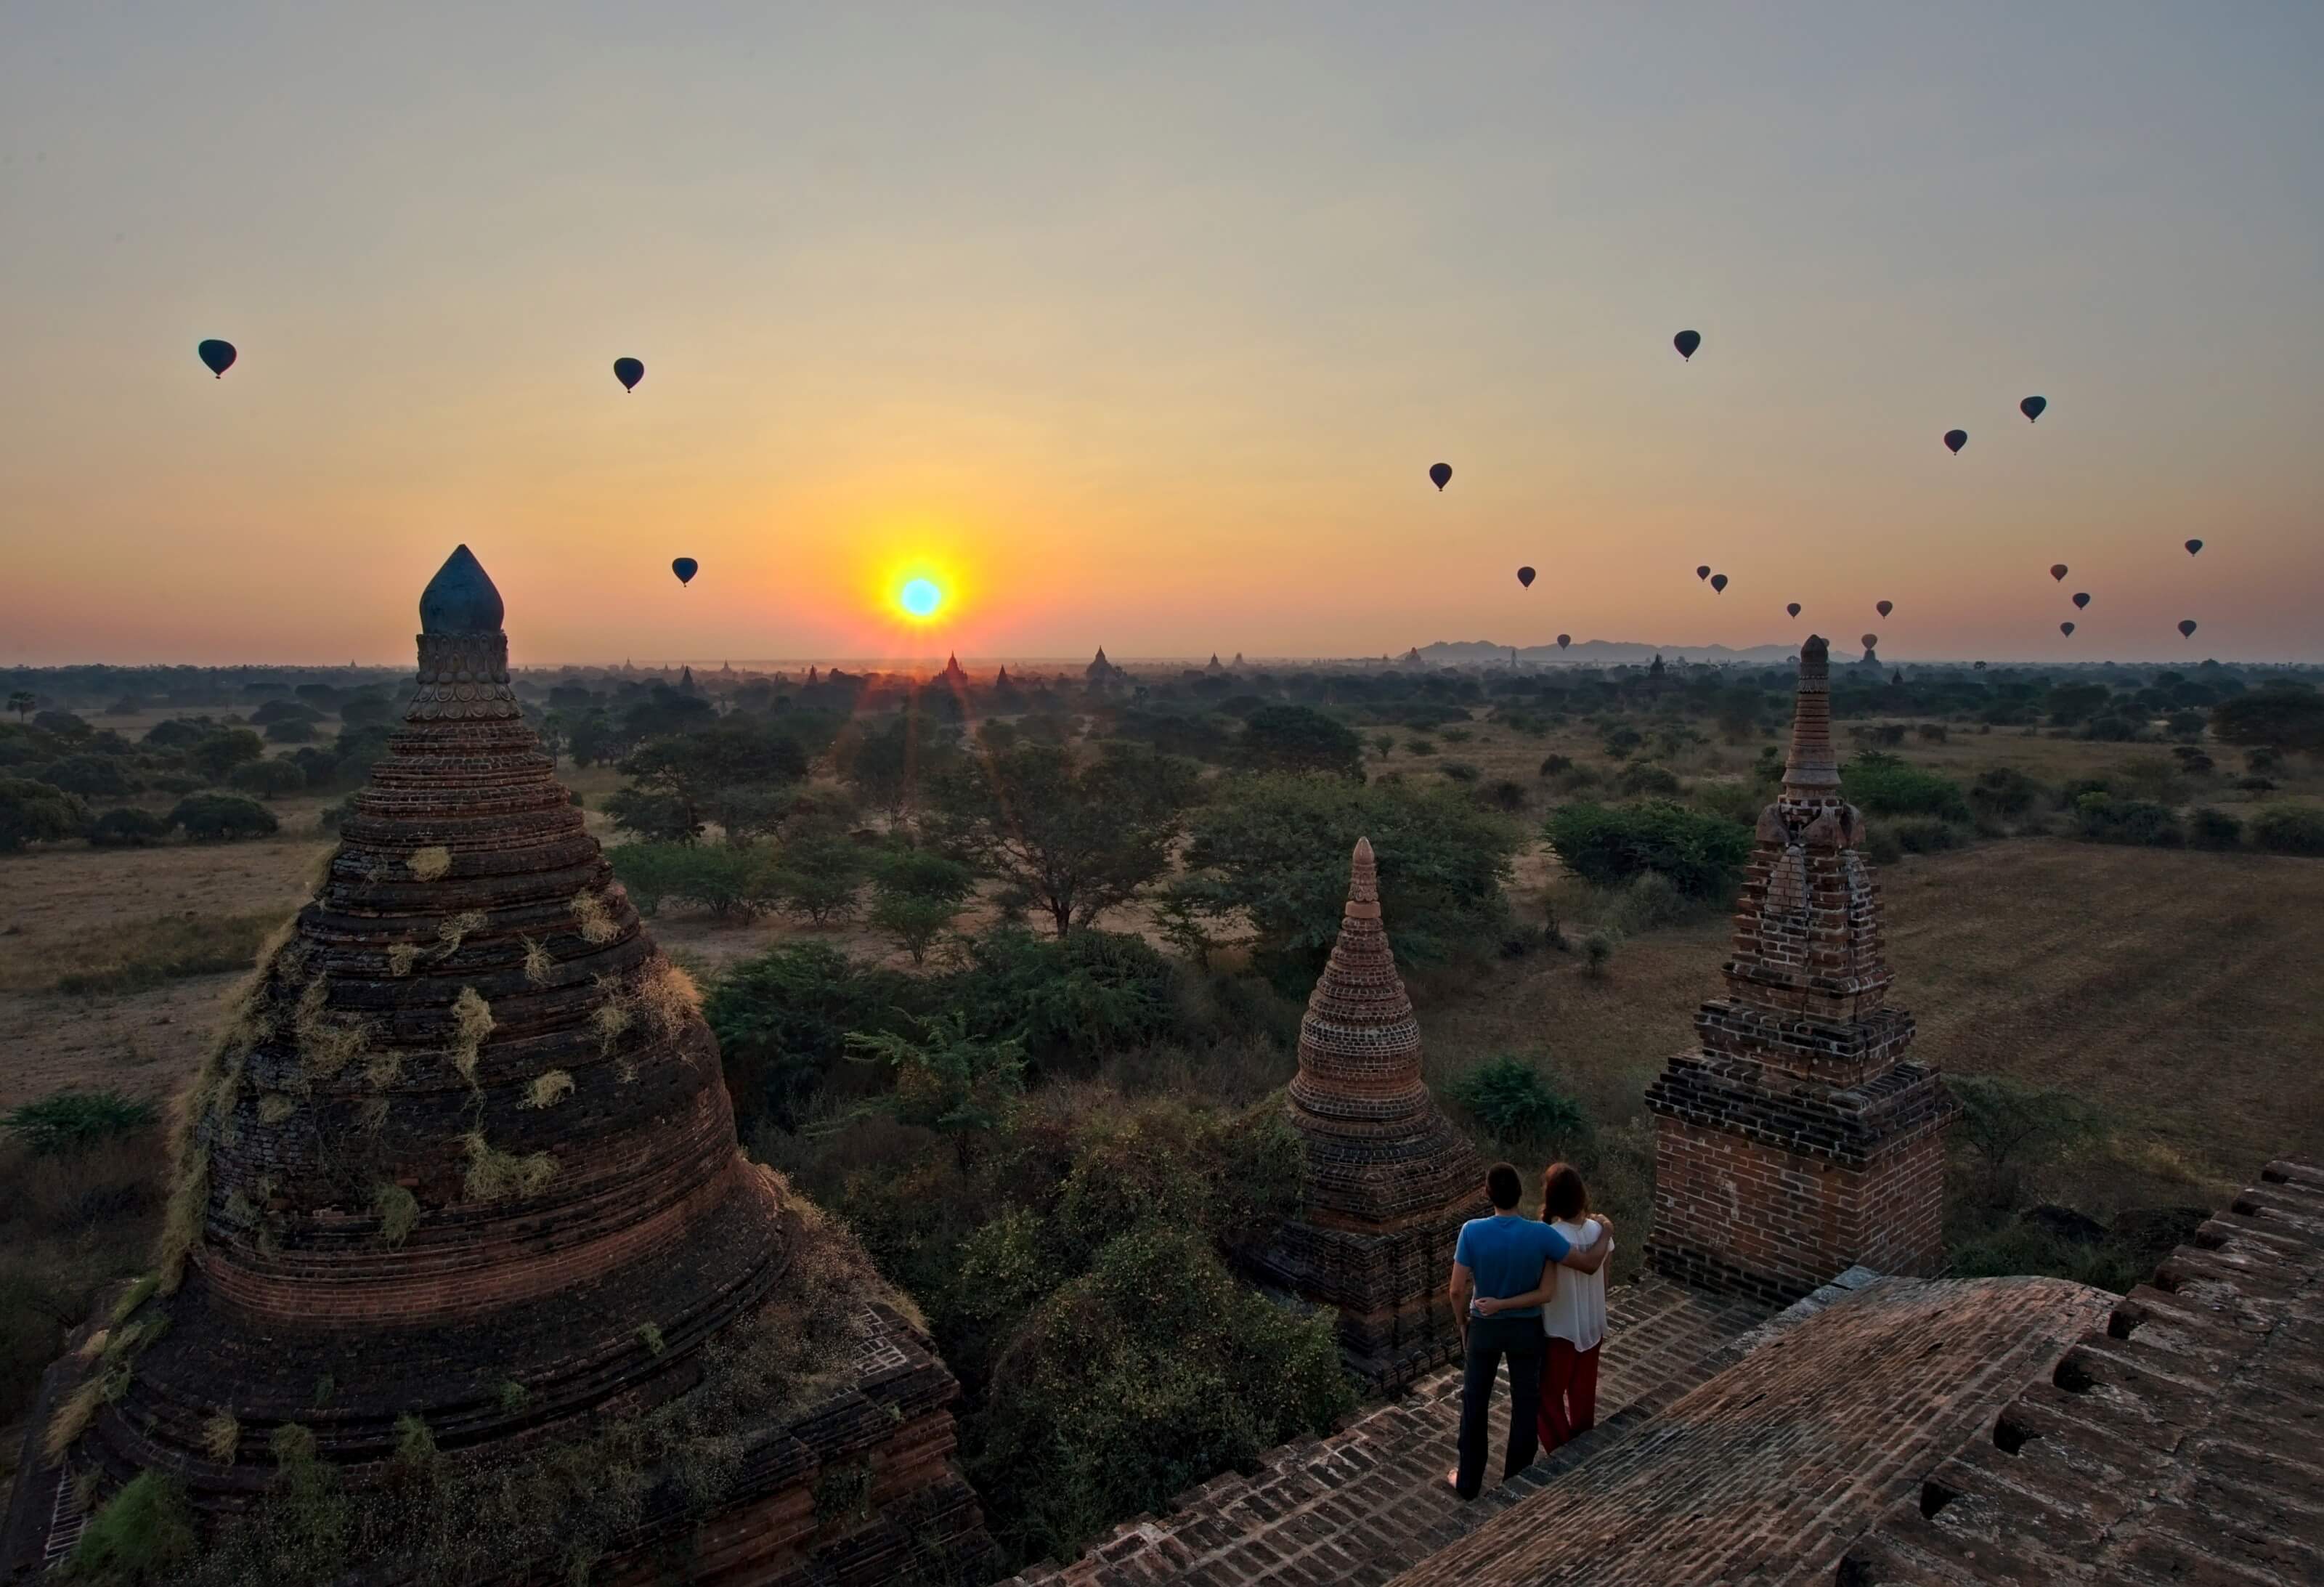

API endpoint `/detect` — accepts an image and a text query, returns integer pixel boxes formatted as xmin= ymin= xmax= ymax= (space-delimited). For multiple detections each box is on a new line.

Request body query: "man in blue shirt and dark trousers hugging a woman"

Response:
xmin=1445 ymin=1162 xmax=1613 ymax=1498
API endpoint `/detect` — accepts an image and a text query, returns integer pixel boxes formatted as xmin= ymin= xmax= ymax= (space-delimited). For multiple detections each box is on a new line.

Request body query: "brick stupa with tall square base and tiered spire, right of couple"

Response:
xmin=1646 ymin=637 xmax=1959 ymax=1302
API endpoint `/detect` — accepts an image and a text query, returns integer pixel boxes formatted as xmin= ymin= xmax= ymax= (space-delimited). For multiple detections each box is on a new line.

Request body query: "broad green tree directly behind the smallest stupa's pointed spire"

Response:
xmin=1176 ymin=776 xmax=1522 ymax=990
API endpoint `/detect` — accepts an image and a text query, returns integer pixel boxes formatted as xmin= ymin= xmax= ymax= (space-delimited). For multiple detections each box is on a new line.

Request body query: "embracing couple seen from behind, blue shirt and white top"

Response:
xmin=1445 ymin=1162 xmax=1613 ymax=1498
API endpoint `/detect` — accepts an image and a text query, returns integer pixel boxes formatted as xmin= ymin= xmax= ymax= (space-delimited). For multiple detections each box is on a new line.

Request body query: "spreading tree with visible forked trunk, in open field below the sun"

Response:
xmin=934 ymin=744 xmax=1199 ymax=936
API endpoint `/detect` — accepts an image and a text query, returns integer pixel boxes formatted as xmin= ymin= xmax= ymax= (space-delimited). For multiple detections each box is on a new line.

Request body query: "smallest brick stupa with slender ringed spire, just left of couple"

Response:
xmin=1241 ymin=839 xmax=1490 ymax=1387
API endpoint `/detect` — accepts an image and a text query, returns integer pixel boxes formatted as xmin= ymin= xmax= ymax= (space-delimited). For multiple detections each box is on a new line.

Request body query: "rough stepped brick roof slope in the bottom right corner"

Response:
xmin=1834 ymin=1162 xmax=2324 ymax=1587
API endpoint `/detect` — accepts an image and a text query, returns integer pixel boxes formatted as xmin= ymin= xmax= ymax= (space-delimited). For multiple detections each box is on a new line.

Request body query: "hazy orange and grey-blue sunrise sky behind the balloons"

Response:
xmin=0 ymin=0 xmax=2324 ymax=665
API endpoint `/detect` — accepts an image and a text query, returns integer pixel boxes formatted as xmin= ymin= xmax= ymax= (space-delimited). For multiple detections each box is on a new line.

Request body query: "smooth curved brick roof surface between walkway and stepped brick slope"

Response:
xmin=1394 ymin=1269 xmax=2113 ymax=1587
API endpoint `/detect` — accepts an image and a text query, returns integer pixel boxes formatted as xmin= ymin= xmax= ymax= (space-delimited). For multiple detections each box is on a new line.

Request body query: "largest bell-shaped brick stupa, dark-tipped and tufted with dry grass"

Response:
xmin=19 ymin=546 xmax=988 ymax=1587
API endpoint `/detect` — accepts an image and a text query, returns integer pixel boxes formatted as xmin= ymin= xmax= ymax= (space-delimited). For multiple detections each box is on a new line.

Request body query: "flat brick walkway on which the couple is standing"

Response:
xmin=990 ymin=1275 xmax=1768 ymax=1587
